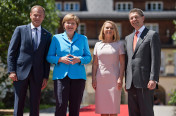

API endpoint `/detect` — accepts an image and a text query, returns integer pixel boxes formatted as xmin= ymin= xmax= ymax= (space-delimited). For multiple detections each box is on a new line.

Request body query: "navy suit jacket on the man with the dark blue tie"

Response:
xmin=7 ymin=24 xmax=51 ymax=82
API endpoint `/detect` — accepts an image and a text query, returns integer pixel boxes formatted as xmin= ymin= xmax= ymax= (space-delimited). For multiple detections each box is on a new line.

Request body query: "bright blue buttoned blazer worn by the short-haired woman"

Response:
xmin=47 ymin=32 xmax=92 ymax=80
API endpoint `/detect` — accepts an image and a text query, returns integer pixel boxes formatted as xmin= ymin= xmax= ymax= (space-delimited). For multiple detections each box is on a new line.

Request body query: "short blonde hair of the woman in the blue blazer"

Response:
xmin=62 ymin=13 xmax=80 ymax=27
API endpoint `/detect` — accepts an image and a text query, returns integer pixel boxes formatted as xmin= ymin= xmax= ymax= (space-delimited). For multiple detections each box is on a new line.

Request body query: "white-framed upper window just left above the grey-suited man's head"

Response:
xmin=115 ymin=2 xmax=133 ymax=11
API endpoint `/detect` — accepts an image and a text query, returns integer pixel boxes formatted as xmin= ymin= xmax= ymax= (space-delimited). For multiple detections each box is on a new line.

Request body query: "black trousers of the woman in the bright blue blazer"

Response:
xmin=54 ymin=76 xmax=85 ymax=116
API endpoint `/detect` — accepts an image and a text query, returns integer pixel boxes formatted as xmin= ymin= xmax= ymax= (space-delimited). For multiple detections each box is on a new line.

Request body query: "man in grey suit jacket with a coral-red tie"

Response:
xmin=125 ymin=8 xmax=161 ymax=116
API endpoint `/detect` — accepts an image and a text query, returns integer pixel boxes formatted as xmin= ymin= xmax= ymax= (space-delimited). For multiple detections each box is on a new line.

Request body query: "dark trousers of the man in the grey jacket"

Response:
xmin=128 ymin=85 xmax=154 ymax=116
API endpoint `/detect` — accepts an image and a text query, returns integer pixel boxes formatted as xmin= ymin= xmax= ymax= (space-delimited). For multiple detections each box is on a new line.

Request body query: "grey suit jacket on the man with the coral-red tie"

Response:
xmin=125 ymin=28 xmax=161 ymax=89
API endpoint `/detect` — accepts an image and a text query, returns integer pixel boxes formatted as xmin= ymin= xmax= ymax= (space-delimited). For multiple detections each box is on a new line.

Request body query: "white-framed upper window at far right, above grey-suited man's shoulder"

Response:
xmin=145 ymin=2 xmax=163 ymax=11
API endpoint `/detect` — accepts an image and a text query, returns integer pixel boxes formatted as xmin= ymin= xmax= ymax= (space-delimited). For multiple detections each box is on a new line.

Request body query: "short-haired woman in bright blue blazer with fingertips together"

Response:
xmin=47 ymin=14 xmax=91 ymax=116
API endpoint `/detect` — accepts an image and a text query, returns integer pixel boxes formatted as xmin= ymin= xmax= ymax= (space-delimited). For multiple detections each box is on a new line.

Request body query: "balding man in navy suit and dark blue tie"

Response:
xmin=7 ymin=5 xmax=51 ymax=116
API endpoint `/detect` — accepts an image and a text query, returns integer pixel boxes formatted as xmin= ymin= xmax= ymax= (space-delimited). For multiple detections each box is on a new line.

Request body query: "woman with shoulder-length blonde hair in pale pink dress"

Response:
xmin=92 ymin=21 xmax=125 ymax=116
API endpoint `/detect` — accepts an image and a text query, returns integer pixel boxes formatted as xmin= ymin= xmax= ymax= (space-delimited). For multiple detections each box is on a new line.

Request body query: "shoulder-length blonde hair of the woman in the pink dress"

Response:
xmin=98 ymin=21 xmax=120 ymax=41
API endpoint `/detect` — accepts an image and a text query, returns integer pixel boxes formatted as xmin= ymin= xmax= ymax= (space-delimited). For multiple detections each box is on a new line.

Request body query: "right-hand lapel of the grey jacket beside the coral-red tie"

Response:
xmin=134 ymin=28 xmax=149 ymax=54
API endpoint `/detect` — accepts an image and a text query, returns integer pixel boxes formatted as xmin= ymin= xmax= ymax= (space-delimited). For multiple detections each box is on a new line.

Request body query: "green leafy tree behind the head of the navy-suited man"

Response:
xmin=0 ymin=0 xmax=59 ymax=64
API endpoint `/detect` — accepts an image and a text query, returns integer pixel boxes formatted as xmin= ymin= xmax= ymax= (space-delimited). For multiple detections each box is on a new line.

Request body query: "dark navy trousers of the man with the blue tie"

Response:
xmin=13 ymin=69 xmax=42 ymax=116
